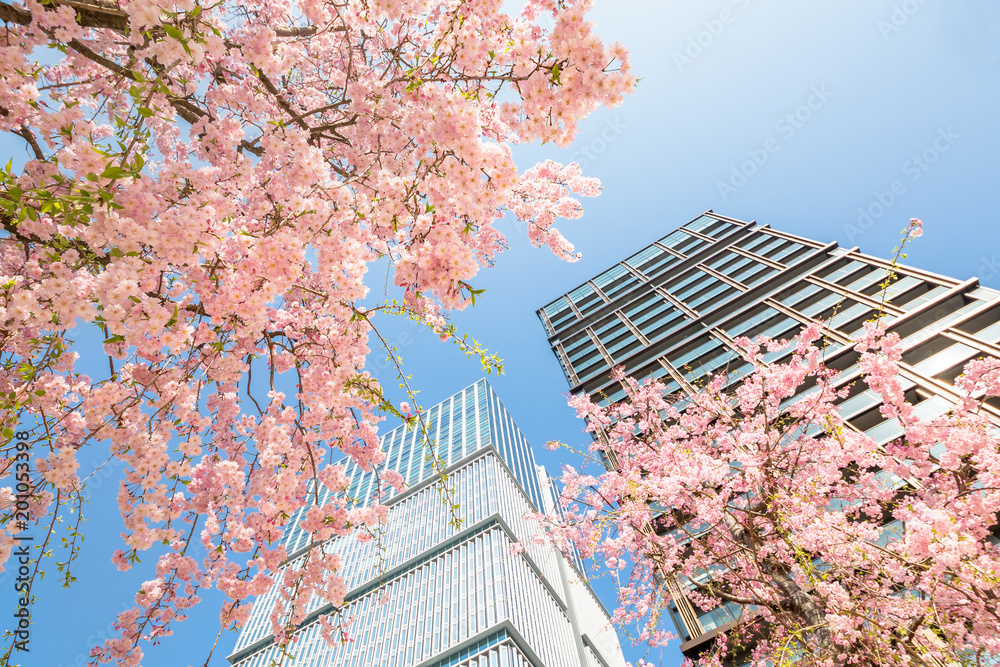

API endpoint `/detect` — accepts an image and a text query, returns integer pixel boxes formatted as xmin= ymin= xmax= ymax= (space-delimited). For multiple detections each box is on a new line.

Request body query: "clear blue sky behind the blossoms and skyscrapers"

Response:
xmin=7 ymin=0 xmax=1000 ymax=667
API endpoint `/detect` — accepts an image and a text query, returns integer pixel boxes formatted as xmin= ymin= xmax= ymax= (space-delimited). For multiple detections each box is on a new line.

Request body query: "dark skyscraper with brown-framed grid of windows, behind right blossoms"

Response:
xmin=538 ymin=211 xmax=1000 ymax=657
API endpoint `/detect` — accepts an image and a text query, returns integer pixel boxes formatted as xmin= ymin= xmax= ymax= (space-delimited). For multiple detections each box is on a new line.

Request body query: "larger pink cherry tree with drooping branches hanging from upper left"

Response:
xmin=0 ymin=0 xmax=635 ymax=665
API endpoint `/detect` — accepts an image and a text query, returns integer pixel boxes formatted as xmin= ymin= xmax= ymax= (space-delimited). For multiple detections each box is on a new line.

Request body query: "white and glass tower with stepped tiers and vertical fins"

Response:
xmin=229 ymin=380 xmax=625 ymax=667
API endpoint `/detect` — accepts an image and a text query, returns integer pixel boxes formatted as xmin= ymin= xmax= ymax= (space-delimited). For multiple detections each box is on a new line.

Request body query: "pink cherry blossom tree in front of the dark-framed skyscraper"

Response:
xmin=546 ymin=236 xmax=1000 ymax=667
